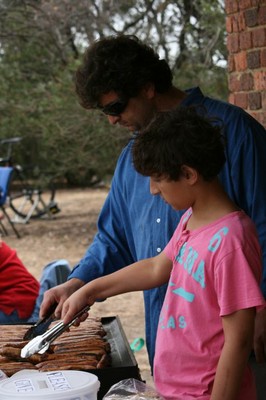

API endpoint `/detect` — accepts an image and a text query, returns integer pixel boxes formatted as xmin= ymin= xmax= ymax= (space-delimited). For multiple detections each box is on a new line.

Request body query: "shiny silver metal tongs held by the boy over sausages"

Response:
xmin=20 ymin=306 xmax=90 ymax=358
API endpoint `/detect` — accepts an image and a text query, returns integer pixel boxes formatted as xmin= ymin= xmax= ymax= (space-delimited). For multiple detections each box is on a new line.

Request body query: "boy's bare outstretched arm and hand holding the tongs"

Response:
xmin=62 ymin=252 xmax=172 ymax=324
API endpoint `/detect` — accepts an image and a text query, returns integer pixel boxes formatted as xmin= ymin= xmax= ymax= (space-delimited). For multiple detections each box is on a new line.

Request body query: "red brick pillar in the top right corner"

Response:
xmin=225 ymin=0 xmax=266 ymax=128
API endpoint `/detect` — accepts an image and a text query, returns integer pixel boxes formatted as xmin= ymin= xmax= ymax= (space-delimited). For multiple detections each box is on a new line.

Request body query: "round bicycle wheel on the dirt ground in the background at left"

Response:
xmin=9 ymin=166 xmax=60 ymax=223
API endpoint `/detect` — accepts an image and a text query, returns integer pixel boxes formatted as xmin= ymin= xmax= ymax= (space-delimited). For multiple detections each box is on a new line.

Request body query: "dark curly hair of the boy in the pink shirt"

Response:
xmin=132 ymin=107 xmax=225 ymax=181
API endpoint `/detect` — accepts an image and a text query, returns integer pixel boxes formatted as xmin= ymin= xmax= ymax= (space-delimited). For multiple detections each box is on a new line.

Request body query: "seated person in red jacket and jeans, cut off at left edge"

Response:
xmin=0 ymin=240 xmax=70 ymax=324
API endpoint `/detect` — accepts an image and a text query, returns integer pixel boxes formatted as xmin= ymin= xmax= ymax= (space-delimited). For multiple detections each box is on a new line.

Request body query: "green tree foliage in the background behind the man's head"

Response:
xmin=0 ymin=0 xmax=227 ymax=185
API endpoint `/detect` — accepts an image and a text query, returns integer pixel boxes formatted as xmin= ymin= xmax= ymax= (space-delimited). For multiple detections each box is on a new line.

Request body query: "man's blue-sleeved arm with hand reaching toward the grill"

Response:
xmin=40 ymin=145 xmax=138 ymax=318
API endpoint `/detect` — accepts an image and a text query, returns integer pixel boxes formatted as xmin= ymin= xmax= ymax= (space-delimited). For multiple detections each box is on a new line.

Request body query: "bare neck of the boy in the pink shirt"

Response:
xmin=187 ymin=179 xmax=239 ymax=230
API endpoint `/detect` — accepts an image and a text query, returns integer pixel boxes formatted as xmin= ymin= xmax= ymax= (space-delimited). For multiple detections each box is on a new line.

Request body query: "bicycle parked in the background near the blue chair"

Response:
xmin=0 ymin=137 xmax=60 ymax=223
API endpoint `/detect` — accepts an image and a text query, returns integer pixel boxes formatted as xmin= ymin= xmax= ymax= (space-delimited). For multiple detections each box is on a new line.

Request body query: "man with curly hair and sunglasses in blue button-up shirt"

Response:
xmin=41 ymin=35 xmax=266 ymax=378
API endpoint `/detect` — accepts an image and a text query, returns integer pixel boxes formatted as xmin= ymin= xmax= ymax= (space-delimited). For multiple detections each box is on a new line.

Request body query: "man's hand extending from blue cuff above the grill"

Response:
xmin=40 ymin=278 xmax=84 ymax=319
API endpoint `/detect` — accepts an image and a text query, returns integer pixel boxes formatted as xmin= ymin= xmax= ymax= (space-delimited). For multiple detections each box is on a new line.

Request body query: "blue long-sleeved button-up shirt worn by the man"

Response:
xmin=69 ymin=88 xmax=266 ymax=365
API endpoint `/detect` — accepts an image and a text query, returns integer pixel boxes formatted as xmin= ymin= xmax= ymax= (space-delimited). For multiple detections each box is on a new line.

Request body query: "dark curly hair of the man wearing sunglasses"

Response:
xmin=76 ymin=35 xmax=173 ymax=109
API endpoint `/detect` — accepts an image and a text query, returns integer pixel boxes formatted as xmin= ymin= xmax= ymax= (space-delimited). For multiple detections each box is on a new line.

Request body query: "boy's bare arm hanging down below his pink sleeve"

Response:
xmin=211 ymin=308 xmax=255 ymax=400
